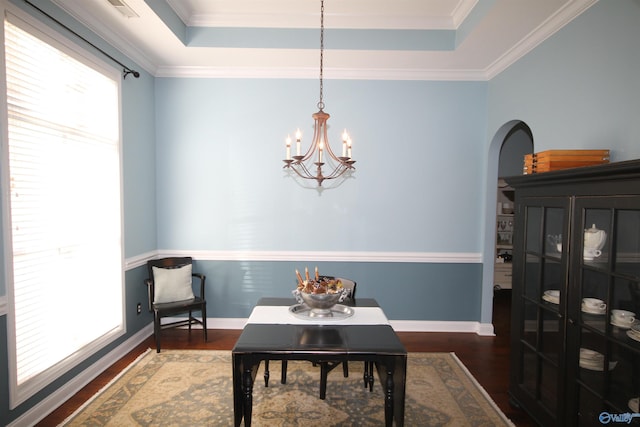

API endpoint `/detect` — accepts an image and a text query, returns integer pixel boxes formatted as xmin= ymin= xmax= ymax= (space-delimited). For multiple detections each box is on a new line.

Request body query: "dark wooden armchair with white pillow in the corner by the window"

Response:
xmin=145 ymin=257 xmax=207 ymax=353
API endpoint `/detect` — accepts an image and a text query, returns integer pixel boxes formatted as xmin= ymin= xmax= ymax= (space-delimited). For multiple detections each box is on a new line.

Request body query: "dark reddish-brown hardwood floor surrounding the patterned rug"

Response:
xmin=38 ymin=291 xmax=535 ymax=427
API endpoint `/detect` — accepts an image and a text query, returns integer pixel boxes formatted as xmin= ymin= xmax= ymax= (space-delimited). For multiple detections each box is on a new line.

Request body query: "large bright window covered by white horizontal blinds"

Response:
xmin=2 ymin=14 xmax=124 ymax=408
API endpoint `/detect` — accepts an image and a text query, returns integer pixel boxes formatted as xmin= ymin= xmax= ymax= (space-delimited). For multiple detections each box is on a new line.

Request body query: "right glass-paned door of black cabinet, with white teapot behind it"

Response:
xmin=567 ymin=196 xmax=640 ymax=426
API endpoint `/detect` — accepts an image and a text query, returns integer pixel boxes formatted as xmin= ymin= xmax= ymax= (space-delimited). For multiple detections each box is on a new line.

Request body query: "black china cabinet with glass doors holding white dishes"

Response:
xmin=507 ymin=160 xmax=640 ymax=426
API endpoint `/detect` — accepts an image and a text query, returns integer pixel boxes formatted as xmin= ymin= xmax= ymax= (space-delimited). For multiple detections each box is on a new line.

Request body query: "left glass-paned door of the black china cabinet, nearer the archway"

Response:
xmin=512 ymin=199 xmax=569 ymax=424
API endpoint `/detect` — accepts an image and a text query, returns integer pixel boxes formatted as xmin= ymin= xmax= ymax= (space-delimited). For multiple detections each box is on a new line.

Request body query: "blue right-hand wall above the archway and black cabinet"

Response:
xmin=488 ymin=0 xmax=640 ymax=161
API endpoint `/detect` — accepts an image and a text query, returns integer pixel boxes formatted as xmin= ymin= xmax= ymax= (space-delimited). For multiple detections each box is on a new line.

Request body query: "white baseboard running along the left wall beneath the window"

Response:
xmin=8 ymin=323 xmax=153 ymax=427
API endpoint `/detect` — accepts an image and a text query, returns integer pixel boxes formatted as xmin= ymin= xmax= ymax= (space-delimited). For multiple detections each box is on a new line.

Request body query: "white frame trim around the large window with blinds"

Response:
xmin=0 ymin=4 xmax=126 ymax=409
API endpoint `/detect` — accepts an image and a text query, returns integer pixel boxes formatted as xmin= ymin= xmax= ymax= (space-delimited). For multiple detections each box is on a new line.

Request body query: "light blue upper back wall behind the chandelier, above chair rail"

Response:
xmin=156 ymin=78 xmax=486 ymax=254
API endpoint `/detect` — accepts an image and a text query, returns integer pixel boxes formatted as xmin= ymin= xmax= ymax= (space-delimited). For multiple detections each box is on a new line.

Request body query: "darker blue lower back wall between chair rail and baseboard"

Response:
xmin=194 ymin=261 xmax=482 ymax=322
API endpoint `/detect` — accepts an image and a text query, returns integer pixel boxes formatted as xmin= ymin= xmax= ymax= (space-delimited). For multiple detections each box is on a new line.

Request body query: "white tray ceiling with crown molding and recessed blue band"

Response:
xmin=52 ymin=0 xmax=597 ymax=80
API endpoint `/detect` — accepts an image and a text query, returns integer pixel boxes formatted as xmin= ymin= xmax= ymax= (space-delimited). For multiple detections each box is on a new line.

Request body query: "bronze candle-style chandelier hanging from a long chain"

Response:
xmin=283 ymin=0 xmax=356 ymax=187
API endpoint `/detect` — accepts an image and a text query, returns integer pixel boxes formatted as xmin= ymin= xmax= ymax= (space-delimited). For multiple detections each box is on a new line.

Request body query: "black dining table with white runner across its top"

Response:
xmin=232 ymin=297 xmax=407 ymax=427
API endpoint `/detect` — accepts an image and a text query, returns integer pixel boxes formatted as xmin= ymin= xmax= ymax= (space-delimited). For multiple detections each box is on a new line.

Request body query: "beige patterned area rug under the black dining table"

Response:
xmin=63 ymin=350 xmax=513 ymax=427
